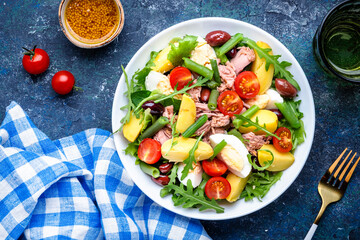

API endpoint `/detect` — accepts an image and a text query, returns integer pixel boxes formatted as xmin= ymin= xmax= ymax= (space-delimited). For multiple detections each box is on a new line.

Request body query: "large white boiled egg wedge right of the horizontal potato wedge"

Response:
xmin=210 ymin=134 xmax=251 ymax=178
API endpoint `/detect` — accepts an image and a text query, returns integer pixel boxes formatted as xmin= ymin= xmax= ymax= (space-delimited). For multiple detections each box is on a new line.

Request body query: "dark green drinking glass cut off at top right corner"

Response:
xmin=313 ymin=0 xmax=360 ymax=83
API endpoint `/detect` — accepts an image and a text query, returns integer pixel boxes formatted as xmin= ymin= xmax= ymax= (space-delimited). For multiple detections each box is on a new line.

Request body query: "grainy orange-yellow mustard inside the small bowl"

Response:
xmin=65 ymin=0 xmax=120 ymax=43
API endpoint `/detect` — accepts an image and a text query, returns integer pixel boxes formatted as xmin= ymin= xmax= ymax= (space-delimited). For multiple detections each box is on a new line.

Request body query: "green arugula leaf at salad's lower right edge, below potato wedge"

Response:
xmin=240 ymin=171 xmax=282 ymax=201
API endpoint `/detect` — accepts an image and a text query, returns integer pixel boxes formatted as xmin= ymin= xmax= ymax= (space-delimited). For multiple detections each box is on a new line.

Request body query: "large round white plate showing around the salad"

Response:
xmin=112 ymin=18 xmax=315 ymax=220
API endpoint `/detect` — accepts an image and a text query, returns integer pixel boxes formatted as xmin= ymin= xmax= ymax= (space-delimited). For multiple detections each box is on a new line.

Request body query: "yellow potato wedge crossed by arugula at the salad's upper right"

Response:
xmin=251 ymin=41 xmax=274 ymax=94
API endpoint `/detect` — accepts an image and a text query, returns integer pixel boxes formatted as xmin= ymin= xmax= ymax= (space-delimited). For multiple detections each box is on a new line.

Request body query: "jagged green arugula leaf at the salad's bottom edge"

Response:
xmin=164 ymin=179 xmax=224 ymax=213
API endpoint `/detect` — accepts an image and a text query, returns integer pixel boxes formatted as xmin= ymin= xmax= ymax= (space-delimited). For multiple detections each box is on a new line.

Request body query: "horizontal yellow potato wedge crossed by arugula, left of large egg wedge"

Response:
xmin=161 ymin=137 xmax=214 ymax=162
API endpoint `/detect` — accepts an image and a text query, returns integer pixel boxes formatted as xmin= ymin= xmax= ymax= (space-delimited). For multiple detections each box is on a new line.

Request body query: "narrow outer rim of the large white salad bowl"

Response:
xmin=112 ymin=17 xmax=315 ymax=220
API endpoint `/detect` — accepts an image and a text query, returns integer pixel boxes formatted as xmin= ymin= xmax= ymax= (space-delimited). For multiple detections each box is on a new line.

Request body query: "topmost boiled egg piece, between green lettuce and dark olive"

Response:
xmin=190 ymin=37 xmax=216 ymax=69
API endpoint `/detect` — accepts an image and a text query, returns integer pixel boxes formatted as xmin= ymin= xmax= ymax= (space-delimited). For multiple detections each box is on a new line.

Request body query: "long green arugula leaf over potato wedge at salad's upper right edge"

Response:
xmin=243 ymin=38 xmax=300 ymax=90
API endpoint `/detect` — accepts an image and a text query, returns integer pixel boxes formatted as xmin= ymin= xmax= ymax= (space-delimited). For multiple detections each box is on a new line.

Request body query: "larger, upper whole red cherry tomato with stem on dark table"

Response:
xmin=22 ymin=46 xmax=50 ymax=74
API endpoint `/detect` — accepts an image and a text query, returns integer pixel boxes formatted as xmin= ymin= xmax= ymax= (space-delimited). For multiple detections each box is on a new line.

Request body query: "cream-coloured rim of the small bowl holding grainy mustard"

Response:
xmin=58 ymin=0 xmax=125 ymax=49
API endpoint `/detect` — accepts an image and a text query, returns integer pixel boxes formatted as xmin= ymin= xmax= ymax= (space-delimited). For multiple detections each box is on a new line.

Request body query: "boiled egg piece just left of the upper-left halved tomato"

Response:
xmin=145 ymin=71 xmax=174 ymax=95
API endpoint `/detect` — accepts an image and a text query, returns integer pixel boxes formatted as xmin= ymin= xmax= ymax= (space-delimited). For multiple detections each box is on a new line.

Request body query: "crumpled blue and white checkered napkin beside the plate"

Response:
xmin=0 ymin=102 xmax=210 ymax=239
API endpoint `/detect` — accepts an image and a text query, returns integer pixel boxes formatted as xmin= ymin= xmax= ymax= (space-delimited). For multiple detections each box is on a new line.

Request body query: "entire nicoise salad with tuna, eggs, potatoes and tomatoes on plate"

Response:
xmin=119 ymin=30 xmax=305 ymax=213
